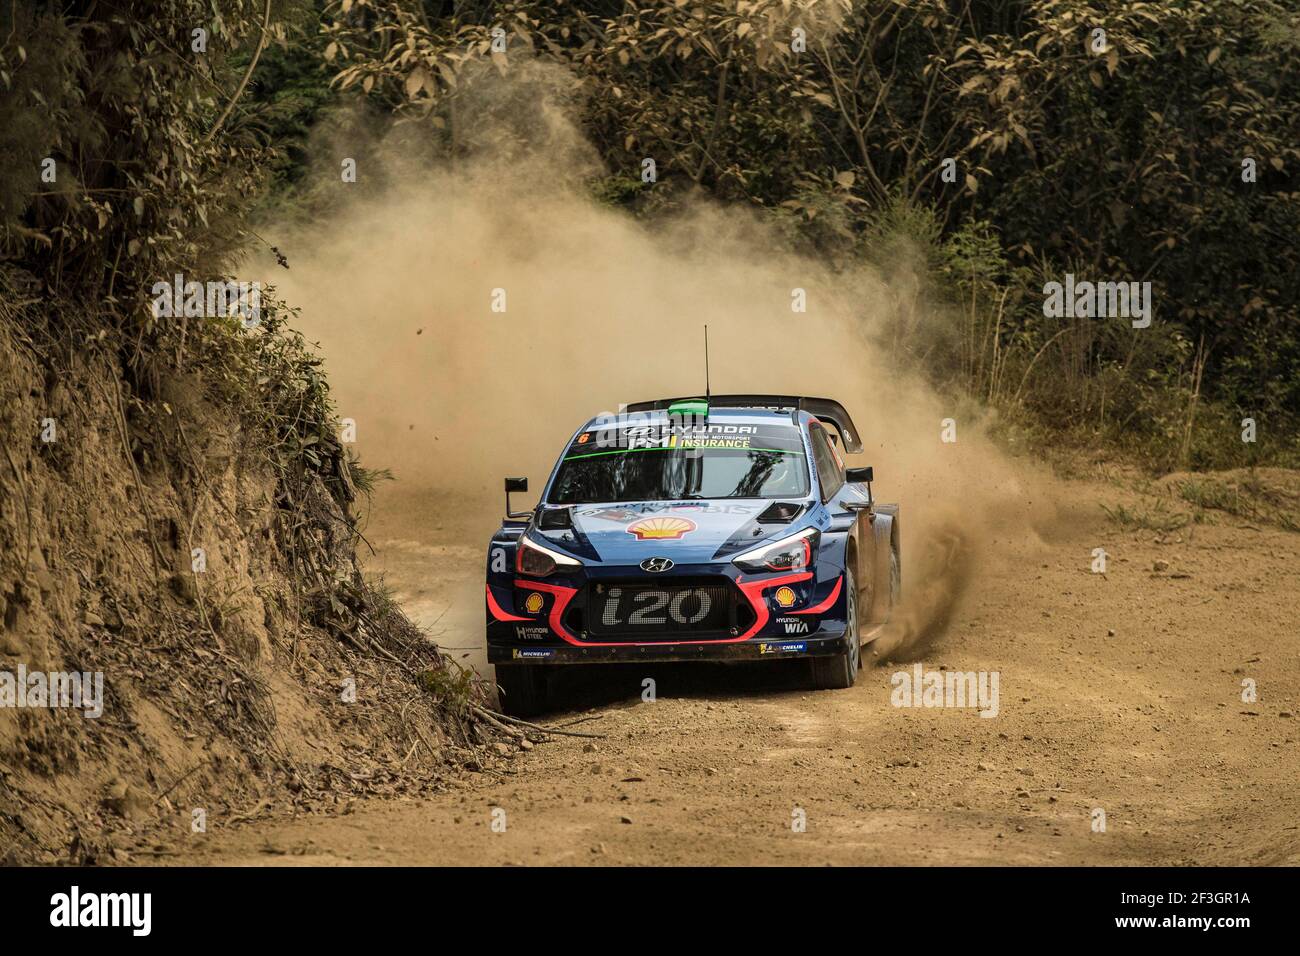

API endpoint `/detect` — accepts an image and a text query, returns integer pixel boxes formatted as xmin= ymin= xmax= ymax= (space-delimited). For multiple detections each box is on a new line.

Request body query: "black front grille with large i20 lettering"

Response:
xmin=584 ymin=578 xmax=754 ymax=641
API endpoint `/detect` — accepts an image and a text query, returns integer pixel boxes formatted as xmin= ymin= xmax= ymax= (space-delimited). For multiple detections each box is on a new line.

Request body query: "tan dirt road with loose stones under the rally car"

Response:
xmin=185 ymin=483 xmax=1300 ymax=865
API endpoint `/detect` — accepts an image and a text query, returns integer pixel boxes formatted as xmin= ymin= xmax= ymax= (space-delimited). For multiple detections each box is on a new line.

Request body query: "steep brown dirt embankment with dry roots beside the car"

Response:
xmin=0 ymin=297 xmax=493 ymax=864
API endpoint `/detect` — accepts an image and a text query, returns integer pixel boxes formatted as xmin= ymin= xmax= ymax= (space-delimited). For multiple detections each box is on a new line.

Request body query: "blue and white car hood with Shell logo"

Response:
xmin=545 ymin=498 xmax=805 ymax=564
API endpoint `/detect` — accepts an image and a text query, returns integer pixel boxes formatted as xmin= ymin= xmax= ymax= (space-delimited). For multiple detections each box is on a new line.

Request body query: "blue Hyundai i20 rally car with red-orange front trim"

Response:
xmin=486 ymin=395 xmax=901 ymax=715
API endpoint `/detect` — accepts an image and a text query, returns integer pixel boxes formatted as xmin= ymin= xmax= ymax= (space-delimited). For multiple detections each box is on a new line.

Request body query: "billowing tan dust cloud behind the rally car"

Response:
xmin=268 ymin=67 xmax=1055 ymax=658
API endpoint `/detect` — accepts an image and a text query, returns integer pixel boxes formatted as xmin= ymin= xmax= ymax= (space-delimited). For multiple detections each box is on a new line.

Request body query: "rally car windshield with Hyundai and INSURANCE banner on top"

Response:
xmin=549 ymin=423 xmax=809 ymax=505
